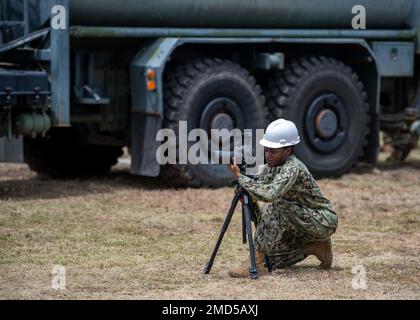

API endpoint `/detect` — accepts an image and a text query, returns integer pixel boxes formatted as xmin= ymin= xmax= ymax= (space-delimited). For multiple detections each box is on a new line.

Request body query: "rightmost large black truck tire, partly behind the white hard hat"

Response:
xmin=266 ymin=57 xmax=369 ymax=178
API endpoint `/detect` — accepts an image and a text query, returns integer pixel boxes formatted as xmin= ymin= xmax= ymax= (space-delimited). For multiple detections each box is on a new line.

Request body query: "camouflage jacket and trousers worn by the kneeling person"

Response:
xmin=239 ymin=155 xmax=338 ymax=268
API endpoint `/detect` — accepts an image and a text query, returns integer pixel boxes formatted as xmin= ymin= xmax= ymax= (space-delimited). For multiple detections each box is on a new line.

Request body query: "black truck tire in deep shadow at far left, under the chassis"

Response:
xmin=24 ymin=129 xmax=123 ymax=178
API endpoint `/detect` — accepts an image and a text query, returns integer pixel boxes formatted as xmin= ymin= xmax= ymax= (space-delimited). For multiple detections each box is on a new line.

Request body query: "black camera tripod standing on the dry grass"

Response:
xmin=204 ymin=181 xmax=259 ymax=279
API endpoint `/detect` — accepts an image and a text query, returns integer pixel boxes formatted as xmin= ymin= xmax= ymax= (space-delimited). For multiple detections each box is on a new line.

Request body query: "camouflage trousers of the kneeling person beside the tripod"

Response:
xmin=254 ymin=199 xmax=338 ymax=269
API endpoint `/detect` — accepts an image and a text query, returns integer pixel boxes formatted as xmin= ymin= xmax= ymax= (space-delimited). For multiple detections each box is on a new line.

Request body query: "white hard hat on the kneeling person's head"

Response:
xmin=260 ymin=119 xmax=300 ymax=149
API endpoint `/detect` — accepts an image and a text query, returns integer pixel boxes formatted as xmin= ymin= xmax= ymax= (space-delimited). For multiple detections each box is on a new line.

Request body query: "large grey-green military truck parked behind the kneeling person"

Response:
xmin=0 ymin=0 xmax=420 ymax=186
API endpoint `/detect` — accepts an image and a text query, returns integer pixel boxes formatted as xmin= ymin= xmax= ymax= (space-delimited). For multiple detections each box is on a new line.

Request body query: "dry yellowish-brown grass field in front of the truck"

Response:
xmin=0 ymin=151 xmax=420 ymax=299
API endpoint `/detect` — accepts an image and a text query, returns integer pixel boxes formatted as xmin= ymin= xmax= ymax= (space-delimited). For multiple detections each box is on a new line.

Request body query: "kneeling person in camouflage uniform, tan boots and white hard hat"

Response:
xmin=229 ymin=119 xmax=338 ymax=277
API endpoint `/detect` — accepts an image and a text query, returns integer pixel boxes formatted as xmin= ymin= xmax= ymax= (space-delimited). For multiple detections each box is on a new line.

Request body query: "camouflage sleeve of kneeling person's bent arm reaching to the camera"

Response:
xmin=238 ymin=162 xmax=299 ymax=202
